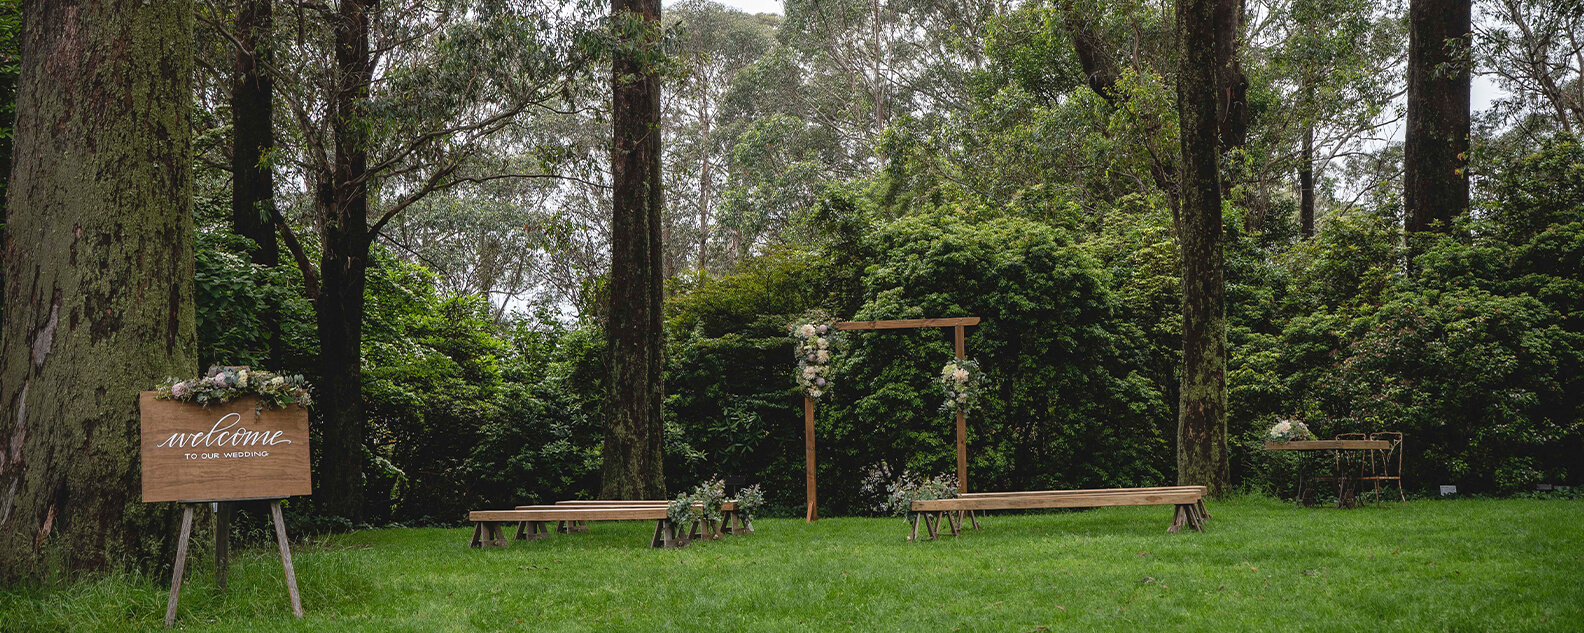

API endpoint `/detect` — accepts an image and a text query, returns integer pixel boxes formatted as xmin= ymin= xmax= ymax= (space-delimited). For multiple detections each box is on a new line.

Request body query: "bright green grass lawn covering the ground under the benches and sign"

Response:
xmin=0 ymin=498 xmax=1584 ymax=633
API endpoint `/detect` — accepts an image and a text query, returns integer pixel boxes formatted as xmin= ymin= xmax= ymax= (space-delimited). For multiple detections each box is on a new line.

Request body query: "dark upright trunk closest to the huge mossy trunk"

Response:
xmin=231 ymin=0 xmax=280 ymax=369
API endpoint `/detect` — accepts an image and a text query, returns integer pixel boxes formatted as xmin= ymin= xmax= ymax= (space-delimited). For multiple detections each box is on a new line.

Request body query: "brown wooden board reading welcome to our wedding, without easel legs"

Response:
xmin=139 ymin=391 xmax=314 ymax=503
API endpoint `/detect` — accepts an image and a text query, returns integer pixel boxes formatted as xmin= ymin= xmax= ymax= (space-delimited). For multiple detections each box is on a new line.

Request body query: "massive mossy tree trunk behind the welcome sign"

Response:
xmin=0 ymin=0 xmax=198 ymax=579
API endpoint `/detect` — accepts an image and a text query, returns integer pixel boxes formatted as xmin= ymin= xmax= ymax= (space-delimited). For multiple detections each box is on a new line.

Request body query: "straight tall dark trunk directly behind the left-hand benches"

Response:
xmin=600 ymin=0 xmax=665 ymax=498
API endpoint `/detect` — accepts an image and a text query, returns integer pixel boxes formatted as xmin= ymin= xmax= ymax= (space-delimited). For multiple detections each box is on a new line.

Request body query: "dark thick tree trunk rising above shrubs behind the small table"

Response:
xmin=1402 ymin=0 xmax=1473 ymax=233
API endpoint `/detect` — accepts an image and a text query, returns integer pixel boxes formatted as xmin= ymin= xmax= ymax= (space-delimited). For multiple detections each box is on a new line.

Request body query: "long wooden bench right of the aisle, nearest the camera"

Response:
xmin=908 ymin=486 xmax=1210 ymax=540
